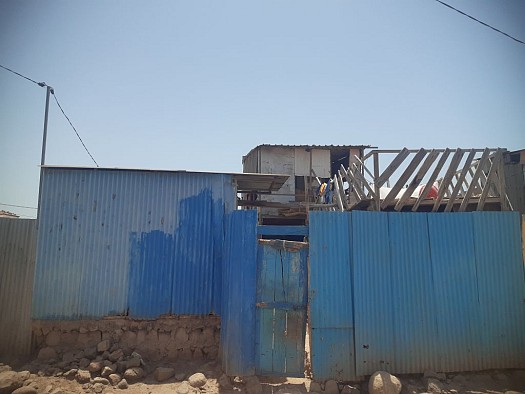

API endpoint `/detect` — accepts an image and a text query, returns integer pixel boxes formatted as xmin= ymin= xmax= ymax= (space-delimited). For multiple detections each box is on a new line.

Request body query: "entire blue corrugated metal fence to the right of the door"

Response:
xmin=310 ymin=211 xmax=525 ymax=380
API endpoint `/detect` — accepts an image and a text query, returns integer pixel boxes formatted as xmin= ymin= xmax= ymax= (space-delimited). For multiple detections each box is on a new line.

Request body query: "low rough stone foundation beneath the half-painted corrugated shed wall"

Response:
xmin=32 ymin=316 xmax=220 ymax=361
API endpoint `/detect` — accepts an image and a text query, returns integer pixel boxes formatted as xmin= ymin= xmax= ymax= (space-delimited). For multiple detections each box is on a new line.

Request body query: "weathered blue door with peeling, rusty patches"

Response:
xmin=255 ymin=240 xmax=308 ymax=377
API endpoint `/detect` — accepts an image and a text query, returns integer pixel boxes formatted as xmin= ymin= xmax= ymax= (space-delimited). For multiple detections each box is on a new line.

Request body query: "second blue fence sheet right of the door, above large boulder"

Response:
xmin=352 ymin=212 xmax=395 ymax=376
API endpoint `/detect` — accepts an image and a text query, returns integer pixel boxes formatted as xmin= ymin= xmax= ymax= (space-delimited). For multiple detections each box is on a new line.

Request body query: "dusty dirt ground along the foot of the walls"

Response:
xmin=0 ymin=362 xmax=525 ymax=394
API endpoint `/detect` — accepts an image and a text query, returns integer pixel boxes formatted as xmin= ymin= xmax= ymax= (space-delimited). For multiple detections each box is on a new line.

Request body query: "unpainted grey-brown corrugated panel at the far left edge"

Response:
xmin=0 ymin=218 xmax=36 ymax=359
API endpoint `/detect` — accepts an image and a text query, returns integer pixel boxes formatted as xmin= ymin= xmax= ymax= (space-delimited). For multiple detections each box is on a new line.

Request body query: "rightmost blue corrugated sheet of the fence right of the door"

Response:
xmin=472 ymin=212 xmax=525 ymax=369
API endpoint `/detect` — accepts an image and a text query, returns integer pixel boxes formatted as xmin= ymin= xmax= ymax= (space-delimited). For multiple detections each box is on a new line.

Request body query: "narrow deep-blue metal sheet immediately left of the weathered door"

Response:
xmin=221 ymin=210 xmax=257 ymax=376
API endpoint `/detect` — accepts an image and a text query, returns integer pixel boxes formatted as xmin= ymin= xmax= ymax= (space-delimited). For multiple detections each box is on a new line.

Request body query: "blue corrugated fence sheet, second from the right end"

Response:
xmin=428 ymin=213 xmax=482 ymax=372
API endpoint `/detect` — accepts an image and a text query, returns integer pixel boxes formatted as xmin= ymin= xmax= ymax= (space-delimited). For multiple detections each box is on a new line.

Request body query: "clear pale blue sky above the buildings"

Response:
xmin=0 ymin=0 xmax=525 ymax=217
